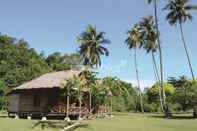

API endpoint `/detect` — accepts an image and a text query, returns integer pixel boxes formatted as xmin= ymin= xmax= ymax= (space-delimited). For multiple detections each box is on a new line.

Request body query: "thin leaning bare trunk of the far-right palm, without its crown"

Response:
xmin=179 ymin=21 xmax=195 ymax=80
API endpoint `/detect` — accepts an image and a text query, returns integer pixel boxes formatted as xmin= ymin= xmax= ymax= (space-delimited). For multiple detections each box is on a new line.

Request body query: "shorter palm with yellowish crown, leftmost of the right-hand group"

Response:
xmin=125 ymin=24 xmax=144 ymax=112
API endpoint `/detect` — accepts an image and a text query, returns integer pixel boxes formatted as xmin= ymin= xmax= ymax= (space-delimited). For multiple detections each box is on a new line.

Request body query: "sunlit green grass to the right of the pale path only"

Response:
xmin=76 ymin=114 xmax=197 ymax=131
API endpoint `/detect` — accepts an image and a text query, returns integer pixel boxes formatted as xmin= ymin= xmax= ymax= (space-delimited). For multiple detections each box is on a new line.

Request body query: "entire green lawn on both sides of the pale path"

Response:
xmin=0 ymin=114 xmax=197 ymax=131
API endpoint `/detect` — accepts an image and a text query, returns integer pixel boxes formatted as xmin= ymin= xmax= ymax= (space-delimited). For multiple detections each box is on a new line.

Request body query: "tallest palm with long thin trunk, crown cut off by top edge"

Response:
xmin=148 ymin=0 xmax=168 ymax=116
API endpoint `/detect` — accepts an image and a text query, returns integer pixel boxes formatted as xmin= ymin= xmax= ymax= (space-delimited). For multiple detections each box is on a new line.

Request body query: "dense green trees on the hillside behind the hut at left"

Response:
xmin=0 ymin=35 xmax=80 ymax=109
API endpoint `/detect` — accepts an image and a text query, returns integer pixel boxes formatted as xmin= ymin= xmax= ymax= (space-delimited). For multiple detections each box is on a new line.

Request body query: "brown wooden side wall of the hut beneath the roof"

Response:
xmin=8 ymin=89 xmax=60 ymax=112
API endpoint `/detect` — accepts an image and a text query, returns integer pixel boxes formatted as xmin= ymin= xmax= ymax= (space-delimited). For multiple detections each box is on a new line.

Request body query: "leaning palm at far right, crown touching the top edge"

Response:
xmin=164 ymin=0 xmax=197 ymax=80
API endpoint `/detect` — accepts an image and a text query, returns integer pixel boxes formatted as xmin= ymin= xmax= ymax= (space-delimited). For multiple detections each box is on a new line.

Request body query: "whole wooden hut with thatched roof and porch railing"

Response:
xmin=8 ymin=70 xmax=88 ymax=117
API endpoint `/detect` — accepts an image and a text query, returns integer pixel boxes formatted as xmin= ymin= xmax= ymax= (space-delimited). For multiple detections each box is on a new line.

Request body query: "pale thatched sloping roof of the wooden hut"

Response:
xmin=13 ymin=70 xmax=81 ymax=90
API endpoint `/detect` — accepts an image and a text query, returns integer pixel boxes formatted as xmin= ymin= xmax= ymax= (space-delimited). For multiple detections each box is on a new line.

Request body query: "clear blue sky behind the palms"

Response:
xmin=0 ymin=0 xmax=197 ymax=87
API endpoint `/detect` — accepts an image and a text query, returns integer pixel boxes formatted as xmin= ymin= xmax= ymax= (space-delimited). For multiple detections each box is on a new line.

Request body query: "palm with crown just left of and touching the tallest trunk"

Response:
xmin=140 ymin=16 xmax=164 ymax=112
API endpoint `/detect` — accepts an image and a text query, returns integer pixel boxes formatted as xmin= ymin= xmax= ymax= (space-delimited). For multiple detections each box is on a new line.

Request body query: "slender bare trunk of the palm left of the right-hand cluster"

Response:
xmin=134 ymin=49 xmax=144 ymax=113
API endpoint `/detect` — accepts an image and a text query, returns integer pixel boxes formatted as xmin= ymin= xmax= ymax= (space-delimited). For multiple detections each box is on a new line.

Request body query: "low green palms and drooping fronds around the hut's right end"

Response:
xmin=65 ymin=71 xmax=140 ymax=112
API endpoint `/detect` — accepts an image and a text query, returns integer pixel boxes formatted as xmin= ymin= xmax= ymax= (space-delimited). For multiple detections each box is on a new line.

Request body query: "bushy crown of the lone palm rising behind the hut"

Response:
xmin=77 ymin=25 xmax=110 ymax=67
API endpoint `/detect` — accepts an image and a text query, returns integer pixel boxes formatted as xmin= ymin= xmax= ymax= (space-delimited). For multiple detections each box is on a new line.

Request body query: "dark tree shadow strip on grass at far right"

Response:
xmin=150 ymin=114 xmax=196 ymax=120
